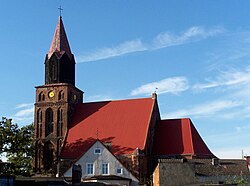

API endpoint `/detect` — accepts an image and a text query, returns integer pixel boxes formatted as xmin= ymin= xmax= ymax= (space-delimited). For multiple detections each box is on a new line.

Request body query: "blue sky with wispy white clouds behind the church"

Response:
xmin=0 ymin=0 xmax=250 ymax=158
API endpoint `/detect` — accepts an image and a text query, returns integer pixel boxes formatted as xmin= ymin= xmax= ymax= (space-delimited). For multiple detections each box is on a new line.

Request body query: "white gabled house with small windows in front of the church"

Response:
xmin=64 ymin=140 xmax=139 ymax=186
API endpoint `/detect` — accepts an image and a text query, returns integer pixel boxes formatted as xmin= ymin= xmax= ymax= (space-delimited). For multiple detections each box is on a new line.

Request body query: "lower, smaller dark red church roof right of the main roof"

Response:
xmin=153 ymin=118 xmax=215 ymax=157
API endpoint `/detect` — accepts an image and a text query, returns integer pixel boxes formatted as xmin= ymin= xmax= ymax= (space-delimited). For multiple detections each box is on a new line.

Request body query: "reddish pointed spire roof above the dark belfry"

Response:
xmin=48 ymin=16 xmax=72 ymax=59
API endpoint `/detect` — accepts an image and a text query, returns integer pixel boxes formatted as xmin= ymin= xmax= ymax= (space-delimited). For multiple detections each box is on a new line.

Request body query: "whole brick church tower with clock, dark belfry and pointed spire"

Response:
xmin=34 ymin=16 xmax=83 ymax=173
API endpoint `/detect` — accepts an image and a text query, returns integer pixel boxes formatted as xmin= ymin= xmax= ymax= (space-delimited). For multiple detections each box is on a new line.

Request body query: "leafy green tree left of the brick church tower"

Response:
xmin=0 ymin=117 xmax=34 ymax=176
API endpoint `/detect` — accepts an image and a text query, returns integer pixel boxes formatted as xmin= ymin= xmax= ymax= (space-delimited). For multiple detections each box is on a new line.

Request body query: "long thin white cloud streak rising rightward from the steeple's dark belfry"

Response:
xmin=77 ymin=26 xmax=225 ymax=63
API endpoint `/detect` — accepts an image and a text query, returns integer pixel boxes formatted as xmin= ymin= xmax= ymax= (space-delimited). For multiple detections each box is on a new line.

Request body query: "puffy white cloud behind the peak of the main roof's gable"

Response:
xmin=130 ymin=77 xmax=188 ymax=96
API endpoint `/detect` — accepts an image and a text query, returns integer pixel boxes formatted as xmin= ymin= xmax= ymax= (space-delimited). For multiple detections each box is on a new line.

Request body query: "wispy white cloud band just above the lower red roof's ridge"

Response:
xmin=163 ymin=100 xmax=240 ymax=119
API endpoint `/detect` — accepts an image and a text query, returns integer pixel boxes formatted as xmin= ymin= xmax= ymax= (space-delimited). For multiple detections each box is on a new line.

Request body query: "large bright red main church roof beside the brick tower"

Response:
xmin=61 ymin=98 xmax=155 ymax=159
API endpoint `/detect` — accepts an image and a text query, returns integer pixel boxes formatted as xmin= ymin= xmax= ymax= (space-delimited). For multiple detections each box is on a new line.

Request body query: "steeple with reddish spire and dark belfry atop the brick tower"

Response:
xmin=45 ymin=16 xmax=75 ymax=86
